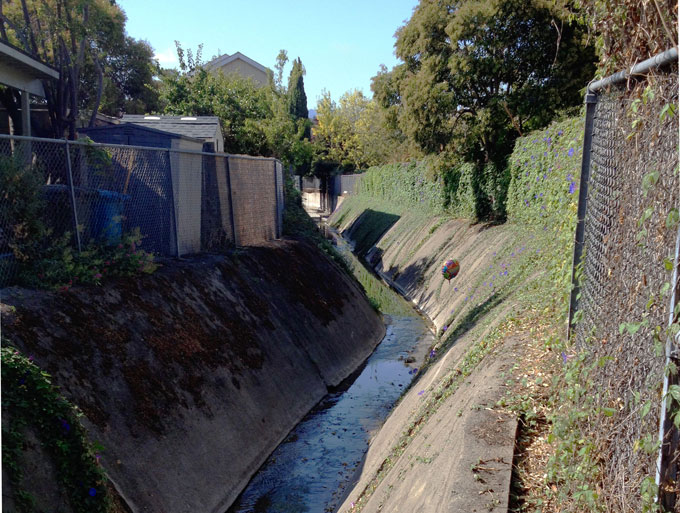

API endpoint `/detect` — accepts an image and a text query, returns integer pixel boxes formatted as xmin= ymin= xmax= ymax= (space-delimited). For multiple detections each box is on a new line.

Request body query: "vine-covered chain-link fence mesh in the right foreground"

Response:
xmin=570 ymin=53 xmax=680 ymax=511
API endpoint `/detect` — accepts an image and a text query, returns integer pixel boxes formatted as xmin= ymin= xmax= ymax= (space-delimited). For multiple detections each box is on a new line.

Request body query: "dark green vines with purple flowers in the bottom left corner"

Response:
xmin=0 ymin=341 xmax=112 ymax=513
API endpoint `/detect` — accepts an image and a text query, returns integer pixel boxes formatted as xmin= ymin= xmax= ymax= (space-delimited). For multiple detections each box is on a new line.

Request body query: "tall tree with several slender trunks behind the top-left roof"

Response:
xmin=0 ymin=0 xmax=141 ymax=138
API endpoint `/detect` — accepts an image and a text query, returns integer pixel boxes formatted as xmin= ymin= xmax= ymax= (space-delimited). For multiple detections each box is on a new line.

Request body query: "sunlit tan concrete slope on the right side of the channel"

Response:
xmin=331 ymin=213 xmax=535 ymax=512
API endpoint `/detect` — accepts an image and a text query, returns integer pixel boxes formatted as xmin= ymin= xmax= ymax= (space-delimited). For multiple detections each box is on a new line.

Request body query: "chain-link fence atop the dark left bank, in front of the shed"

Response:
xmin=0 ymin=135 xmax=283 ymax=285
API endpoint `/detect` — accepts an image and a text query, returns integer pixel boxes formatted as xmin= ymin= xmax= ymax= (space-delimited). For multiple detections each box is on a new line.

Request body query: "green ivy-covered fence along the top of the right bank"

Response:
xmin=348 ymin=117 xmax=583 ymax=226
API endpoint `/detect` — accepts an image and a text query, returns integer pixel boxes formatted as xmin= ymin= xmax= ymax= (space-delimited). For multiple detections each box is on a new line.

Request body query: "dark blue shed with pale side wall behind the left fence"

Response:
xmin=78 ymin=123 xmax=204 ymax=255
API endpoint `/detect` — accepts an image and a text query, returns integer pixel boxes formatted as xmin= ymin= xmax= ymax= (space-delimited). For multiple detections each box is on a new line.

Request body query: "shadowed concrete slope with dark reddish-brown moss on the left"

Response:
xmin=3 ymin=241 xmax=384 ymax=513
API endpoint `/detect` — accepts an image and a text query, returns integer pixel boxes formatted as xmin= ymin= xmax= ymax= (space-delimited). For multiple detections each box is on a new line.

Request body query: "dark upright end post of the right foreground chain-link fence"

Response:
xmin=567 ymin=93 xmax=598 ymax=339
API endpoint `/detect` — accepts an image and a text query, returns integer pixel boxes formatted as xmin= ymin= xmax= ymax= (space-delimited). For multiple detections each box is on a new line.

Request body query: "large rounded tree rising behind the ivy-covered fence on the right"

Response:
xmin=372 ymin=0 xmax=595 ymax=216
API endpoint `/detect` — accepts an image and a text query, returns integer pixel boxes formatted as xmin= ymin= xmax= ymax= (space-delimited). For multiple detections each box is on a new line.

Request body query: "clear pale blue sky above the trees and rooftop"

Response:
xmin=117 ymin=0 xmax=418 ymax=109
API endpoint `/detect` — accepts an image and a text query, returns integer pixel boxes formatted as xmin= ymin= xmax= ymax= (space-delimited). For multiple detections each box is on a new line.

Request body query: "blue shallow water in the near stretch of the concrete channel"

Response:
xmin=228 ymin=315 xmax=432 ymax=513
